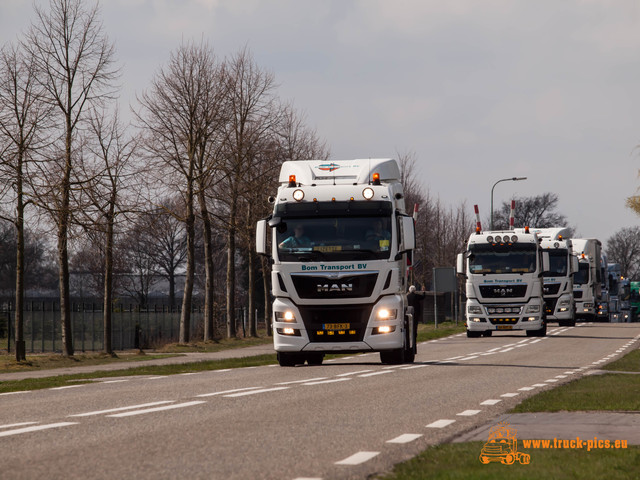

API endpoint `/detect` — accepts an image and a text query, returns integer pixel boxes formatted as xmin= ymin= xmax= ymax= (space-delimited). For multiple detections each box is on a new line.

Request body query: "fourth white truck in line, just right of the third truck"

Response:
xmin=571 ymin=238 xmax=602 ymax=321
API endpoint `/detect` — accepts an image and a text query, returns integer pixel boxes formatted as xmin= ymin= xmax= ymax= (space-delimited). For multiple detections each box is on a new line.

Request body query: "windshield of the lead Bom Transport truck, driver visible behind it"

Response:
xmin=276 ymin=215 xmax=392 ymax=262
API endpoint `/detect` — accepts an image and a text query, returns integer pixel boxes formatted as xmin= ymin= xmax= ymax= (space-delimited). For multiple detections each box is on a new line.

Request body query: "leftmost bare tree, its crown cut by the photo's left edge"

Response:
xmin=0 ymin=44 xmax=50 ymax=361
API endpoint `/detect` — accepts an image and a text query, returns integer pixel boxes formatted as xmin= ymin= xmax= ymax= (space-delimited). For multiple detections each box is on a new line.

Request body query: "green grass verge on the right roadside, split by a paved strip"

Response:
xmin=378 ymin=349 xmax=640 ymax=480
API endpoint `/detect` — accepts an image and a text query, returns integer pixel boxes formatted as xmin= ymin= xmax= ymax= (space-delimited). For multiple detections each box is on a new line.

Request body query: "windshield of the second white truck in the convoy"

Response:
xmin=469 ymin=243 xmax=537 ymax=274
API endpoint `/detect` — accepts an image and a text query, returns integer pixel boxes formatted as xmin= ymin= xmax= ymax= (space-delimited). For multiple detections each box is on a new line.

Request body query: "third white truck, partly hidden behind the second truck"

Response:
xmin=516 ymin=227 xmax=578 ymax=326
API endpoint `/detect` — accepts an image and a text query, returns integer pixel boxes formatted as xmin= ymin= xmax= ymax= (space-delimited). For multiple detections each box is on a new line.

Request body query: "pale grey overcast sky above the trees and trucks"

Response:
xmin=0 ymin=0 xmax=640 ymax=243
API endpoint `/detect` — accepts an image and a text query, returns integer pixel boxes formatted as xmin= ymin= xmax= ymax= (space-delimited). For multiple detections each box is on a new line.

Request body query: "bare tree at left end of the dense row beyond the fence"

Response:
xmin=137 ymin=40 xmax=218 ymax=343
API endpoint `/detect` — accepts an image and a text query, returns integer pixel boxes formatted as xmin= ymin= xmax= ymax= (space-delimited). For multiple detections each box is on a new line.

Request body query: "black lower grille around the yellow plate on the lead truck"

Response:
xmin=298 ymin=305 xmax=373 ymax=342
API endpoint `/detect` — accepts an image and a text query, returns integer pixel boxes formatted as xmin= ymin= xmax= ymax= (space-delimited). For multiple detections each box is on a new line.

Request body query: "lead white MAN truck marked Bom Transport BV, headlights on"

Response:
xmin=256 ymin=159 xmax=416 ymax=366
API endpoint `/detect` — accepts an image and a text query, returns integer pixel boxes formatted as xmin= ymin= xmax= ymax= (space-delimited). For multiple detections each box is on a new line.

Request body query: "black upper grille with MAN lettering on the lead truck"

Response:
xmin=291 ymin=273 xmax=378 ymax=299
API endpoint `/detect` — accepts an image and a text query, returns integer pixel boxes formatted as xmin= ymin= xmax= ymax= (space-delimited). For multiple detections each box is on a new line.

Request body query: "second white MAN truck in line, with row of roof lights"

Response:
xmin=456 ymin=227 xmax=549 ymax=337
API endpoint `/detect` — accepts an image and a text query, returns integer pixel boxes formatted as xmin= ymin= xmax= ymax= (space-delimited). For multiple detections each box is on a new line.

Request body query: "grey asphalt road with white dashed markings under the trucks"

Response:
xmin=0 ymin=323 xmax=640 ymax=480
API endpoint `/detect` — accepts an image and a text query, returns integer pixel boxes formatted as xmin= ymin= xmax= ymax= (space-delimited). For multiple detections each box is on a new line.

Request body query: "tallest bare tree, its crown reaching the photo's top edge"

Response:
xmin=23 ymin=0 xmax=118 ymax=356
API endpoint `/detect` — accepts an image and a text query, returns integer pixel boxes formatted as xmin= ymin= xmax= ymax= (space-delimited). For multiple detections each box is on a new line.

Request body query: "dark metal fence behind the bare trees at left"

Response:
xmin=0 ymin=300 xmax=258 ymax=353
